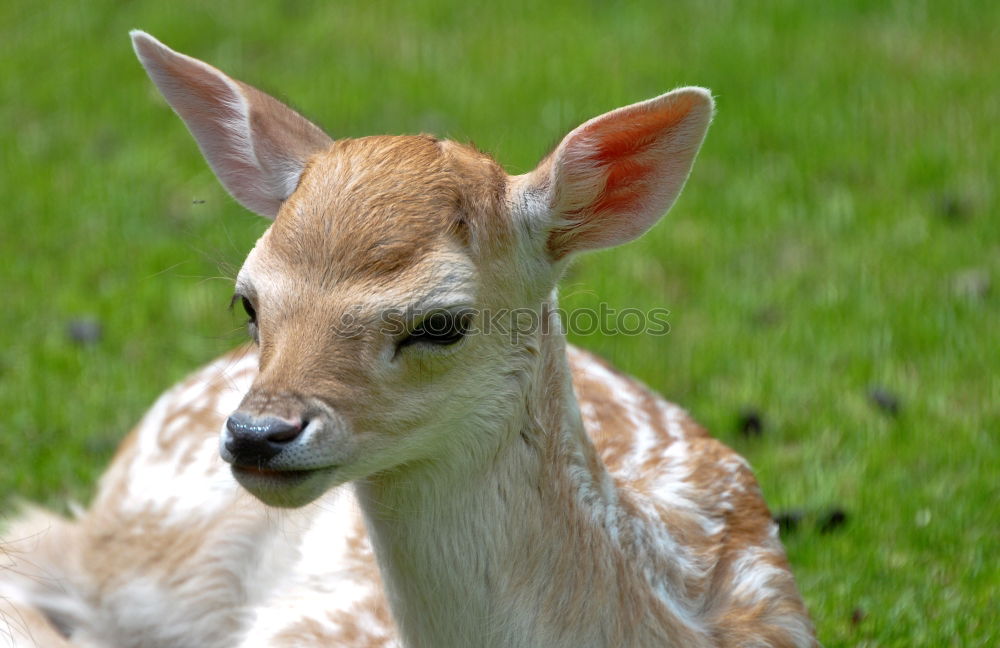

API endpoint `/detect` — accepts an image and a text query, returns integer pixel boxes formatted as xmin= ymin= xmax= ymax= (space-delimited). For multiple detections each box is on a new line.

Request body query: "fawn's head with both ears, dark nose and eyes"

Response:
xmin=132 ymin=32 xmax=713 ymax=506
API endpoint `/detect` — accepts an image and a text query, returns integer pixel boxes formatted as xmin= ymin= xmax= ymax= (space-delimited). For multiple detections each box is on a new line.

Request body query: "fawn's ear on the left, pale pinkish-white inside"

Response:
xmin=131 ymin=30 xmax=332 ymax=218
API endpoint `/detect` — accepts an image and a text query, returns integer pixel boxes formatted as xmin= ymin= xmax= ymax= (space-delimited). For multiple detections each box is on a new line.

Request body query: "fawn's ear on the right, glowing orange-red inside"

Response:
xmin=526 ymin=87 xmax=714 ymax=259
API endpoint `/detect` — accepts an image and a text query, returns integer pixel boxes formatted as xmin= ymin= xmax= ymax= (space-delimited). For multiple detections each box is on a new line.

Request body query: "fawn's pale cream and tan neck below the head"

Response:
xmin=357 ymin=302 xmax=696 ymax=646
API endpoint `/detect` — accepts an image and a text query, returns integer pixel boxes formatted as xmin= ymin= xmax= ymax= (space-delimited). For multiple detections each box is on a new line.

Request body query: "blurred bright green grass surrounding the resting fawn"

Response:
xmin=0 ymin=0 xmax=1000 ymax=646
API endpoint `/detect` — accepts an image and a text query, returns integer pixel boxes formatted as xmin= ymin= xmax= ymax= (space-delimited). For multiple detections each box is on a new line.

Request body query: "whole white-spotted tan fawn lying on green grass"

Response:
xmin=0 ymin=31 xmax=816 ymax=648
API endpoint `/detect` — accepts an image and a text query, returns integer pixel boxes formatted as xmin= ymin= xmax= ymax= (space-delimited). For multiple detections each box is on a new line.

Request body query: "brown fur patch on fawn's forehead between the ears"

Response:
xmin=267 ymin=135 xmax=506 ymax=287
